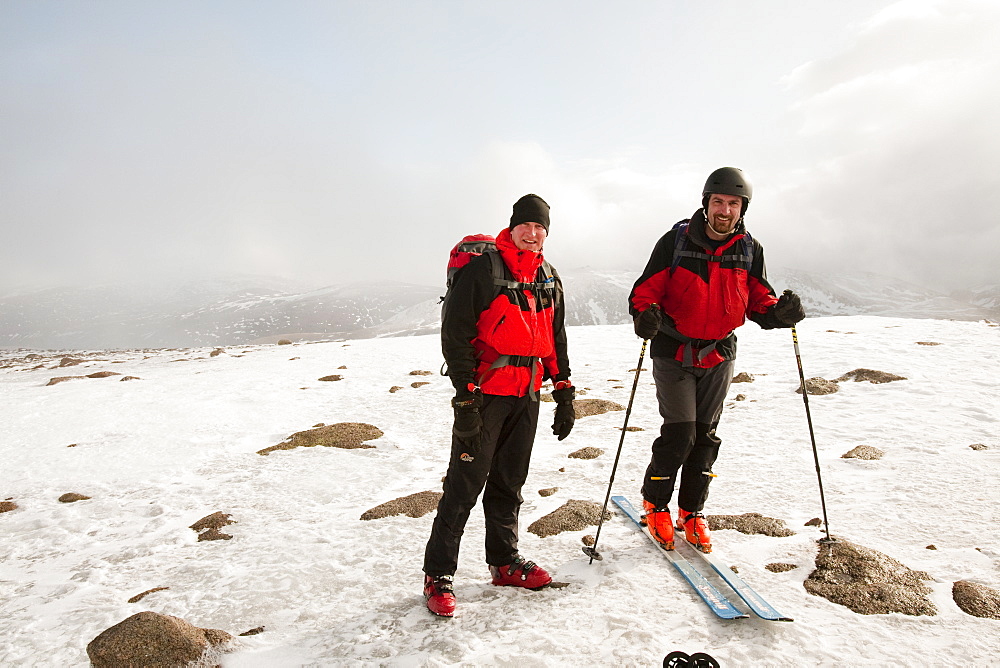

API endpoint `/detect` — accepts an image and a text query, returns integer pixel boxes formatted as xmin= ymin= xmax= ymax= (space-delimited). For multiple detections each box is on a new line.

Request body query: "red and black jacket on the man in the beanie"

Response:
xmin=441 ymin=230 xmax=570 ymax=397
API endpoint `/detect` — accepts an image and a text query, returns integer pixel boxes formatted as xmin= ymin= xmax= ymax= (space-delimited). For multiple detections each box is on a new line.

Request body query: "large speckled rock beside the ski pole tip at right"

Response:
xmin=803 ymin=539 xmax=937 ymax=615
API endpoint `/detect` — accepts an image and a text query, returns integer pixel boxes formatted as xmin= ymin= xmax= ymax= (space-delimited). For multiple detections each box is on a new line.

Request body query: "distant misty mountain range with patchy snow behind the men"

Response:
xmin=0 ymin=268 xmax=1000 ymax=350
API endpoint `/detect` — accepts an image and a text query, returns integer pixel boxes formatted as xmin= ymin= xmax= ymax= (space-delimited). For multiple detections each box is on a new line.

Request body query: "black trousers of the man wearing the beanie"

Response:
xmin=424 ymin=394 xmax=538 ymax=575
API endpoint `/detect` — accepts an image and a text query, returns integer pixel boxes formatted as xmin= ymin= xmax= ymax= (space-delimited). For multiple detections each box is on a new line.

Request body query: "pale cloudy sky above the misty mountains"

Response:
xmin=0 ymin=0 xmax=1000 ymax=292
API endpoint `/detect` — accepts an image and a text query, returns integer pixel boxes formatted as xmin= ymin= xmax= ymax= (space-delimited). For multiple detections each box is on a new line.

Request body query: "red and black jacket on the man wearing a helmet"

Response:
xmin=629 ymin=209 xmax=785 ymax=368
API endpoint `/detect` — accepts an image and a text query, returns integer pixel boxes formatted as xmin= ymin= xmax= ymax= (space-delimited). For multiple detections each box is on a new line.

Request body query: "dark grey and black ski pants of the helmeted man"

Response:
xmin=642 ymin=357 xmax=735 ymax=512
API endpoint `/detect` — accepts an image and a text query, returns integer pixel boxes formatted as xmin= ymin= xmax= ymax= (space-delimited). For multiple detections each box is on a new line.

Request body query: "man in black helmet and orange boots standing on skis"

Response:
xmin=629 ymin=167 xmax=805 ymax=552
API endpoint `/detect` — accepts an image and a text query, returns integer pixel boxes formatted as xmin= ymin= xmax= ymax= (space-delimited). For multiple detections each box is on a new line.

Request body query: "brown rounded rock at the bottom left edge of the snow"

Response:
xmin=87 ymin=611 xmax=232 ymax=668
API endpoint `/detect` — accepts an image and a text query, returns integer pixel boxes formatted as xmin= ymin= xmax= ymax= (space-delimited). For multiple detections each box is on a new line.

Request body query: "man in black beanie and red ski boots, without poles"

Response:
xmin=423 ymin=195 xmax=576 ymax=617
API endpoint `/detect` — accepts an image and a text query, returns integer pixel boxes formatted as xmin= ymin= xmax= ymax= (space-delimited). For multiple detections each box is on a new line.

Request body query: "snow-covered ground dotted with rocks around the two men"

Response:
xmin=0 ymin=317 xmax=1000 ymax=668
